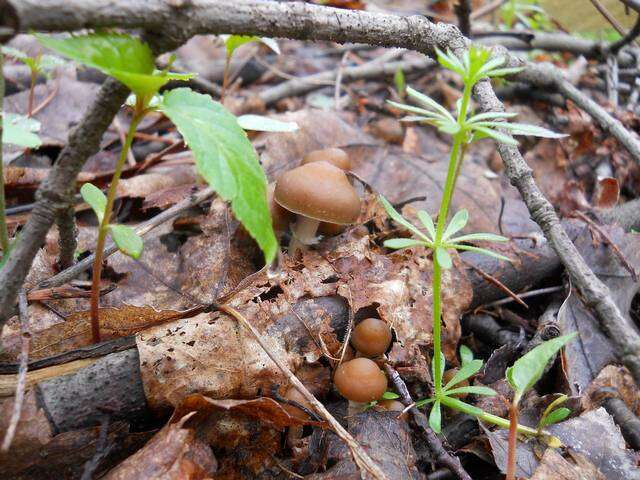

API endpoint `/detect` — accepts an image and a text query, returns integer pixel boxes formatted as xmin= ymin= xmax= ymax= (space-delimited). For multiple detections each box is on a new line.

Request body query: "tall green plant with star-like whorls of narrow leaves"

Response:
xmin=380 ymin=46 xmax=565 ymax=434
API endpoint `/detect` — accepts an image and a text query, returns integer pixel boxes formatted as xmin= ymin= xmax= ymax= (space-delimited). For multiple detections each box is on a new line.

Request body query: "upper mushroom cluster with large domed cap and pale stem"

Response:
xmin=268 ymin=148 xmax=361 ymax=255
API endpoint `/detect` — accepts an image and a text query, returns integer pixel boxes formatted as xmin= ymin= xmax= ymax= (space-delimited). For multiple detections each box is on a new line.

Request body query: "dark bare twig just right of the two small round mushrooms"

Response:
xmin=384 ymin=364 xmax=471 ymax=480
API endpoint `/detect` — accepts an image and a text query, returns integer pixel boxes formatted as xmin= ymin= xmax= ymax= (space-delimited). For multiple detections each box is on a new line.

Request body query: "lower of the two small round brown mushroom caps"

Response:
xmin=333 ymin=357 xmax=387 ymax=403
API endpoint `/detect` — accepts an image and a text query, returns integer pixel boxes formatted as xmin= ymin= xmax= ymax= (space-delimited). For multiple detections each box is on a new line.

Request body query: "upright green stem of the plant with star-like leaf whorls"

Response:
xmin=432 ymin=80 xmax=471 ymax=395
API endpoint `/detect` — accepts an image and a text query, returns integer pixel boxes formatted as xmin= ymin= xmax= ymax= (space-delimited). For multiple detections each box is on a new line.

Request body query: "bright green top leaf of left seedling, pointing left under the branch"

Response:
xmin=36 ymin=32 xmax=193 ymax=97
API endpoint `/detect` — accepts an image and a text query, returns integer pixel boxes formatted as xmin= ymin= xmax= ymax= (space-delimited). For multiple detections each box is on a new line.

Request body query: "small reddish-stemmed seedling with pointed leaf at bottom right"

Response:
xmin=506 ymin=332 xmax=577 ymax=480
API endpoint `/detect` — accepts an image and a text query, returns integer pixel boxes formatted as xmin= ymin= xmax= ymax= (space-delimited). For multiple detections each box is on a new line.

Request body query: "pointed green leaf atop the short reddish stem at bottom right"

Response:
xmin=506 ymin=332 xmax=577 ymax=396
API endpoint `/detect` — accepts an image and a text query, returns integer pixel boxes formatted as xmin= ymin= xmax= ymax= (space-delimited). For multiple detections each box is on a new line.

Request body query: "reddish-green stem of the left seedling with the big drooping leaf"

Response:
xmin=91 ymin=110 xmax=145 ymax=343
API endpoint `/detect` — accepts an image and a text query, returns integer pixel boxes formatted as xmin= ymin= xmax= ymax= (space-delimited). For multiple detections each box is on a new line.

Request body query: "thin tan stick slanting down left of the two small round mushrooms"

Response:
xmin=218 ymin=305 xmax=388 ymax=480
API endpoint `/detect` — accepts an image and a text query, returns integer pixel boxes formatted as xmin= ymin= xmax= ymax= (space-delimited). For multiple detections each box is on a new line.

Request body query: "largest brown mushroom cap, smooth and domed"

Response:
xmin=274 ymin=162 xmax=360 ymax=225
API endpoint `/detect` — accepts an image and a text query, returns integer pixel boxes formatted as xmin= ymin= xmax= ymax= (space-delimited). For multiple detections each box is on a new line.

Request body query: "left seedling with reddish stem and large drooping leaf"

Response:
xmin=38 ymin=33 xmax=282 ymax=342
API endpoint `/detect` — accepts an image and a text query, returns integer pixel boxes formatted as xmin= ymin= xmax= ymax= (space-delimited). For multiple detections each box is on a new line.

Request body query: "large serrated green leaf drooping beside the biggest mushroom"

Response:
xmin=161 ymin=88 xmax=278 ymax=263
